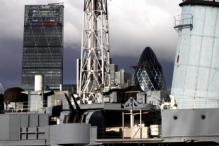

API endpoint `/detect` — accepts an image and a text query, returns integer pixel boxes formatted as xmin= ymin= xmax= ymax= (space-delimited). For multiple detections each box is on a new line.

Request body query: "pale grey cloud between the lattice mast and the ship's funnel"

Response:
xmin=109 ymin=0 xmax=181 ymax=61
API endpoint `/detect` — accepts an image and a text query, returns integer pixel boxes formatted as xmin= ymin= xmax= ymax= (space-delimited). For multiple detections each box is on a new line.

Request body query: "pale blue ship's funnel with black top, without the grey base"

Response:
xmin=171 ymin=0 xmax=219 ymax=109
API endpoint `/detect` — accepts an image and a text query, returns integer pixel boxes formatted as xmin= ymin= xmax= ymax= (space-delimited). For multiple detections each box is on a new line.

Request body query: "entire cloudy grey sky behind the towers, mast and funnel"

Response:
xmin=0 ymin=0 xmax=182 ymax=89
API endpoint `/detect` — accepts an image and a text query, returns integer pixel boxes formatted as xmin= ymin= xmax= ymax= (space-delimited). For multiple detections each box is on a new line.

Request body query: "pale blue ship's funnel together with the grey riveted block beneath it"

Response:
xmin=162 ymin=0 xmax=219 ymax=145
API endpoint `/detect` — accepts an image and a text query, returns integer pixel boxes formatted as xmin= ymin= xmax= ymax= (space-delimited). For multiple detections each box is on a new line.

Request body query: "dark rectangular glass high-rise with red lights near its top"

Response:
xmin=22 ymin=4 xmax=64 ymax=90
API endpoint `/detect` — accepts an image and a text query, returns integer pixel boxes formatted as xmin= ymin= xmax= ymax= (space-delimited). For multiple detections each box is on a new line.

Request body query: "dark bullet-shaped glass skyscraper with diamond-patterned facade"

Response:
xmin=134 ymin=47 xmax=166 ymax=91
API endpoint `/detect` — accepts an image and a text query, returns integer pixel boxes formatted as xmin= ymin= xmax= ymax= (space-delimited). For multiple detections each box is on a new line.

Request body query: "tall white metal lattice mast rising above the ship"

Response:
xmin=79 ymin=0 xmax=110 ymax=98
